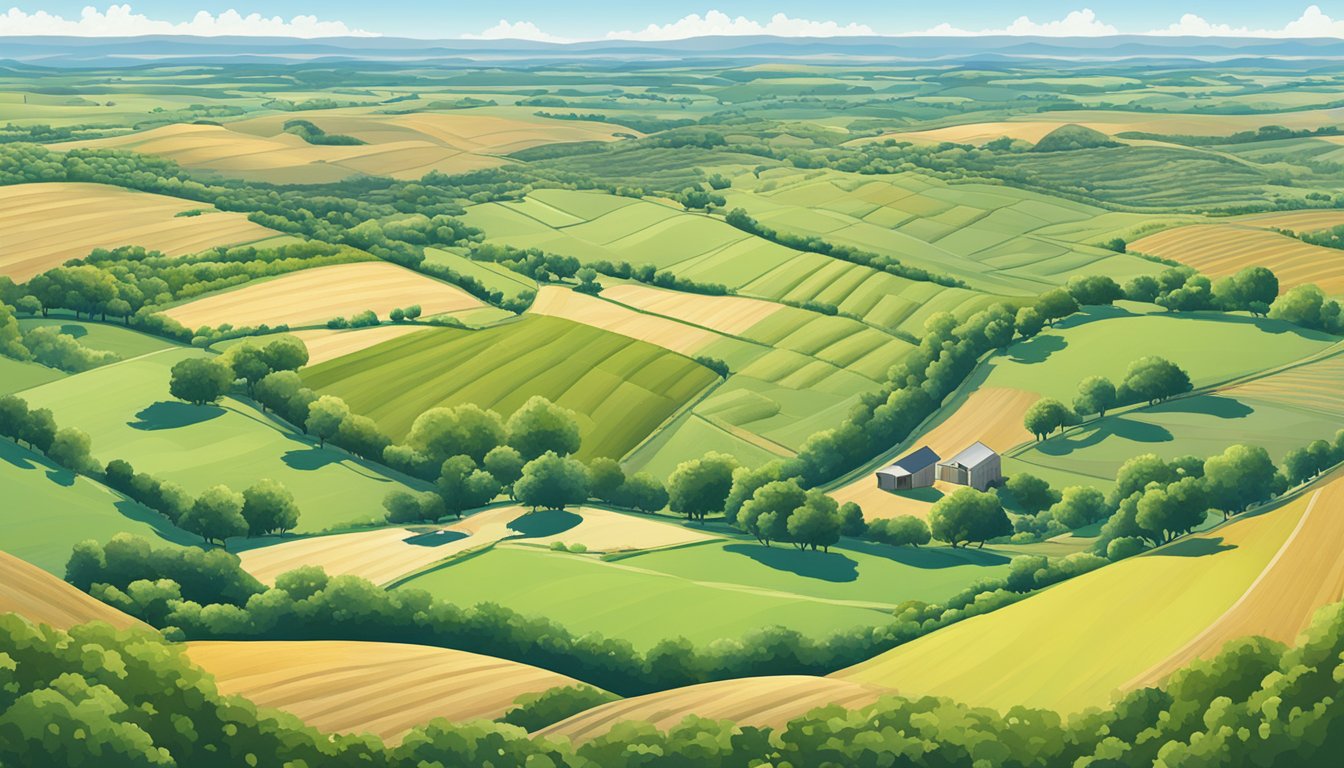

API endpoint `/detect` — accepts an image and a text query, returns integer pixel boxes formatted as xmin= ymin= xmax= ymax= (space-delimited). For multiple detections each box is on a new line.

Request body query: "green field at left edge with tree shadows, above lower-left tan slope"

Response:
xmin=0 ymin=438 xmax=198 ymax=576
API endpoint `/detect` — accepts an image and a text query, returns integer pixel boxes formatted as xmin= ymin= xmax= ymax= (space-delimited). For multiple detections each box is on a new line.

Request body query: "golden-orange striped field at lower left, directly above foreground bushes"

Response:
xmin=187 ymin=640 xmax=577 ymax=742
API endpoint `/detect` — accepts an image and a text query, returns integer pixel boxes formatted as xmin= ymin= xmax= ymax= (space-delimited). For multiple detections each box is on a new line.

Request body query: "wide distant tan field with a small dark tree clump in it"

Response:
xmin=58 ymin=109 xmax=628 ymax=184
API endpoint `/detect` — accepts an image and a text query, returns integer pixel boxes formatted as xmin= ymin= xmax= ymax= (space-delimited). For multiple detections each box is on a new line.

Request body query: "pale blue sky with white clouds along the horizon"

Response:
xmin=0 ymin=0 xmax=1344 ymax=42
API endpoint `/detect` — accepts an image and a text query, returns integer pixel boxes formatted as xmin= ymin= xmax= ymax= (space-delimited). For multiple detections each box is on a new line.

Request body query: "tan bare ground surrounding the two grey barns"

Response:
xmin=831 ymin=387 xmax=1040 ymax=521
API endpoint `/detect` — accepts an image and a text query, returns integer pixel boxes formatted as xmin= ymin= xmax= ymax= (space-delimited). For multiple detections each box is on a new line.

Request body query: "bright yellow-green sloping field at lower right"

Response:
xmin=835 ymin=481 xmax=1328 ymax=713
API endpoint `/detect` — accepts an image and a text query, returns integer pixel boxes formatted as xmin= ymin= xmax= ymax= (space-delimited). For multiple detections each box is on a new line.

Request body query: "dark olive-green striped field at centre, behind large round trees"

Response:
xmin=304 ymin=317 xmax=718 ymax=459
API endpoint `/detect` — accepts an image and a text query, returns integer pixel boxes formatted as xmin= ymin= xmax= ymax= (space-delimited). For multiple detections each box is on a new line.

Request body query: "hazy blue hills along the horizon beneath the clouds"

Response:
xmin=0 ymin=35 xmax=1344 ymax=67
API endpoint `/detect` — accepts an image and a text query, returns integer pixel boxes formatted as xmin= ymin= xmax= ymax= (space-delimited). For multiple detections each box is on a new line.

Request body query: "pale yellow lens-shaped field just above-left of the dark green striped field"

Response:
xmin=164 ymin=261 xmax=484 ymax=328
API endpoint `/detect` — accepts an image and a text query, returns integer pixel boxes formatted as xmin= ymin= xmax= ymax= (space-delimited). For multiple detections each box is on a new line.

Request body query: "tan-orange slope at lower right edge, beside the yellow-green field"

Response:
xmin=1125 ymin=470 xmax=1344 ymax=689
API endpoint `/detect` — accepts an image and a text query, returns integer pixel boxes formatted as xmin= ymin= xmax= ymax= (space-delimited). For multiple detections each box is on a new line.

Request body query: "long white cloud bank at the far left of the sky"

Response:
xmin=0 ymin=4 xmax=372 ymax=38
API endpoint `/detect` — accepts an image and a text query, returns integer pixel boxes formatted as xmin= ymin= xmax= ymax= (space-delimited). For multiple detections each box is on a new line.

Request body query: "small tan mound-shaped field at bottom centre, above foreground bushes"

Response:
xmin=538 ymin=675 xmax=888 ymax=742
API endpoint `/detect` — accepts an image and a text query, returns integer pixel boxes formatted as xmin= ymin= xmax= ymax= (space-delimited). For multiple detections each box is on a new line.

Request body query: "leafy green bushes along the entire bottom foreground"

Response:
xmin=0 ymin=604 xmax=1344 ymax=768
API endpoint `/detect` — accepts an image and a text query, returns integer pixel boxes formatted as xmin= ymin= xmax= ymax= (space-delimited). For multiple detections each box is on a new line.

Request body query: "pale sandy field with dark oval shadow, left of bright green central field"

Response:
xmin=238 ymin=507 xmax=523 ymax=584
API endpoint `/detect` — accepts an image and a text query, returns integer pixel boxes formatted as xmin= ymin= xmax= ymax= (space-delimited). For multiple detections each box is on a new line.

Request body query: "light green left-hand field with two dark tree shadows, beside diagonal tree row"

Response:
xmin=22 ymin=348 xmax=419 ymax=531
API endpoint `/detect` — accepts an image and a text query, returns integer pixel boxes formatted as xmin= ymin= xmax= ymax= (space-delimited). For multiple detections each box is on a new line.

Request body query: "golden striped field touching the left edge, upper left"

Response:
xmin=0 ymin=183 xmax=276 ymax=281
